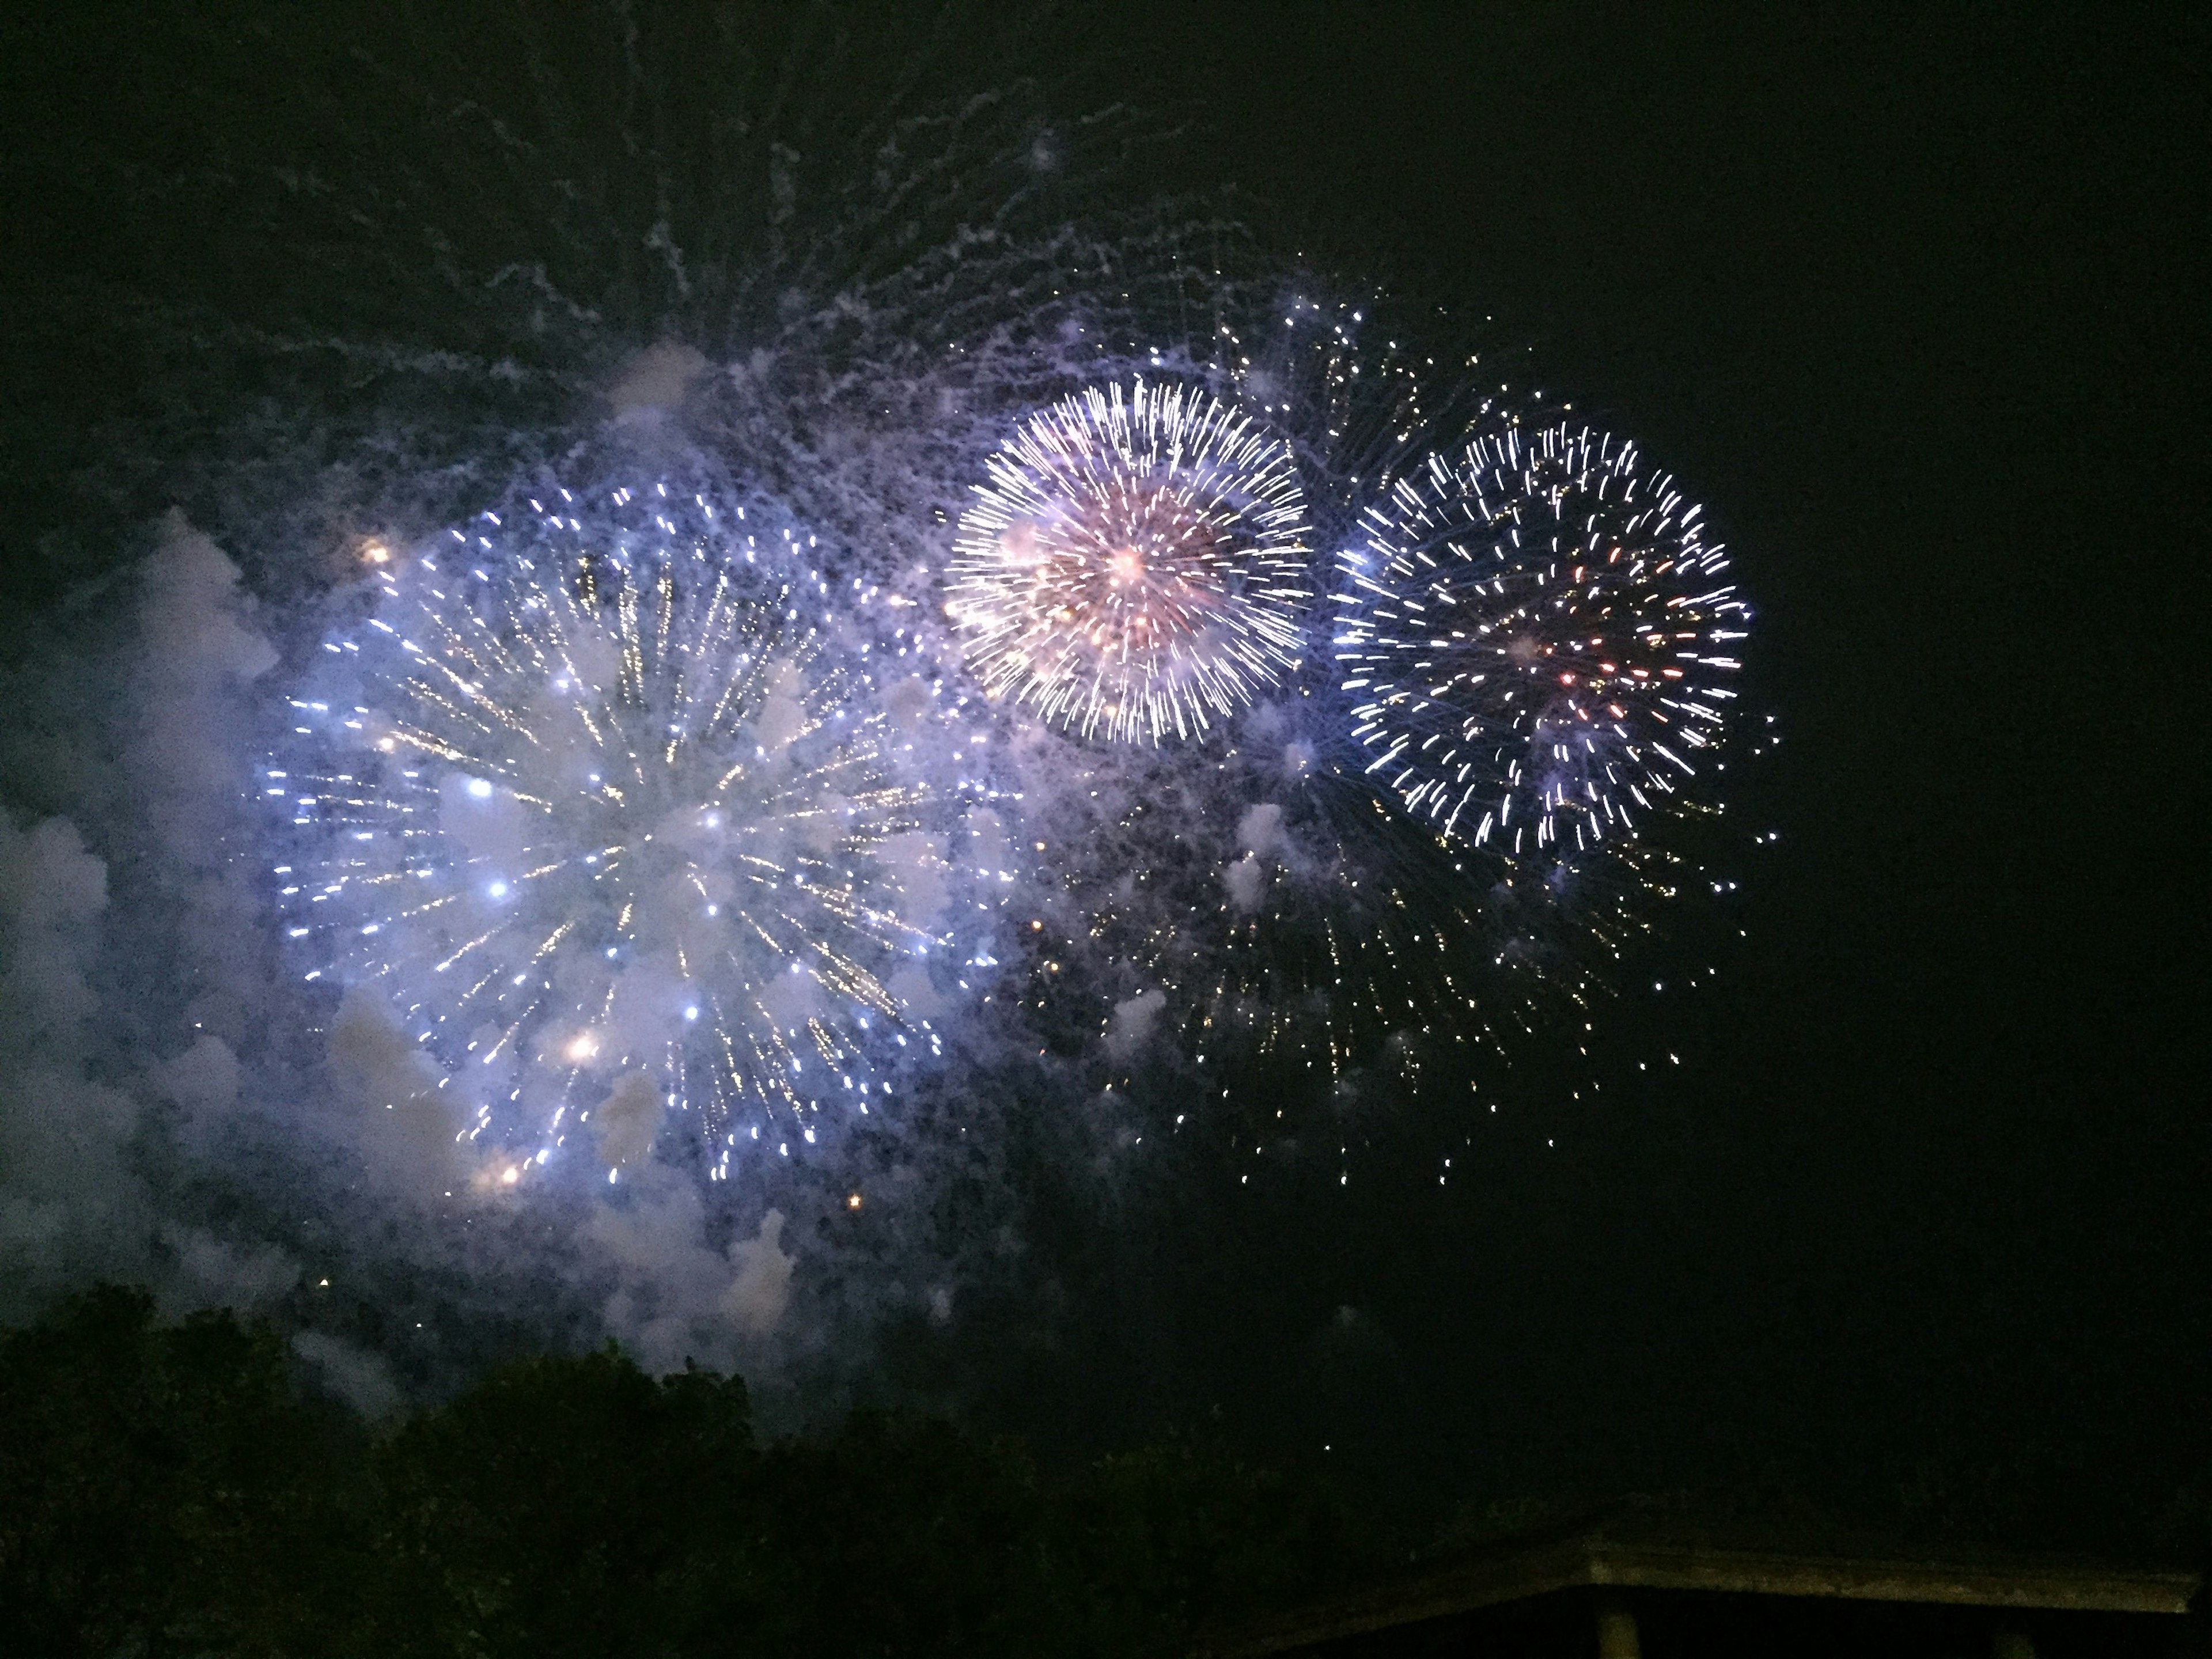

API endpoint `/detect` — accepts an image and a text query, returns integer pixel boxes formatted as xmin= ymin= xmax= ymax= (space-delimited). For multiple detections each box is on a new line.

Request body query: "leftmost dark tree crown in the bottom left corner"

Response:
xmin=0 ymin=1287 xmax=365 ymax=1654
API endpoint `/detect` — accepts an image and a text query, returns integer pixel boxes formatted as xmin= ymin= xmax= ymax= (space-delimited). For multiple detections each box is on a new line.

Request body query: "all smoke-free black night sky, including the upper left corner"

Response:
xmin=0 ymin=5 xmax=2212 ymax=1557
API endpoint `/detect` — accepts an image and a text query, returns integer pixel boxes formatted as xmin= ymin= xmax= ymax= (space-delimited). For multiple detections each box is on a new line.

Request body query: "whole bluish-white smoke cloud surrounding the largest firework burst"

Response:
xmin=0 ymin=32 xmax=1645 ymax=1418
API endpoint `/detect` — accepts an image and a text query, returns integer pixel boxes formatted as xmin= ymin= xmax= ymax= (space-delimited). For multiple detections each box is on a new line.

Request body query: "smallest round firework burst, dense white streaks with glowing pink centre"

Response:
xmin=947 ymin=380 xmax=1309 ymax=743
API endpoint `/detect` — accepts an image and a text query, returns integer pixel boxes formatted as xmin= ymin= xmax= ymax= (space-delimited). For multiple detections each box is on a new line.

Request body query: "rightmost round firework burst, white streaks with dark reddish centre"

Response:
xmin=1336 ymin=425 xmax=1749 ymax=854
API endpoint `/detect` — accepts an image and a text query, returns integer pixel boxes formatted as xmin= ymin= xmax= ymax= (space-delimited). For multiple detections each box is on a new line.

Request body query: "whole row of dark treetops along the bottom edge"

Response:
xmin=0 ymin=1290 xmax=1362 ymax=1659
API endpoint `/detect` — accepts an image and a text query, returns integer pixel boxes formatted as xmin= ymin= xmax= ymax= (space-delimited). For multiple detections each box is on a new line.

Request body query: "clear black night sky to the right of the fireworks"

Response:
xmin=1092 ymin=5 xmax=2212 ymax=1531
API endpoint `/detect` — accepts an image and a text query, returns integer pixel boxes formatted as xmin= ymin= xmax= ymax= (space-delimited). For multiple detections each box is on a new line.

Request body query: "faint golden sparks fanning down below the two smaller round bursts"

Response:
xmin=1002 ymin=701 xmax=1683 ymax=1110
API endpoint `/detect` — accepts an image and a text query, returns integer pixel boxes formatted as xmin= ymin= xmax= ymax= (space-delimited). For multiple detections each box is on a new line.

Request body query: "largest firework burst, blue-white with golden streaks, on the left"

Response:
xmin=263 ymin=487 xmax=945 ymax=1175
